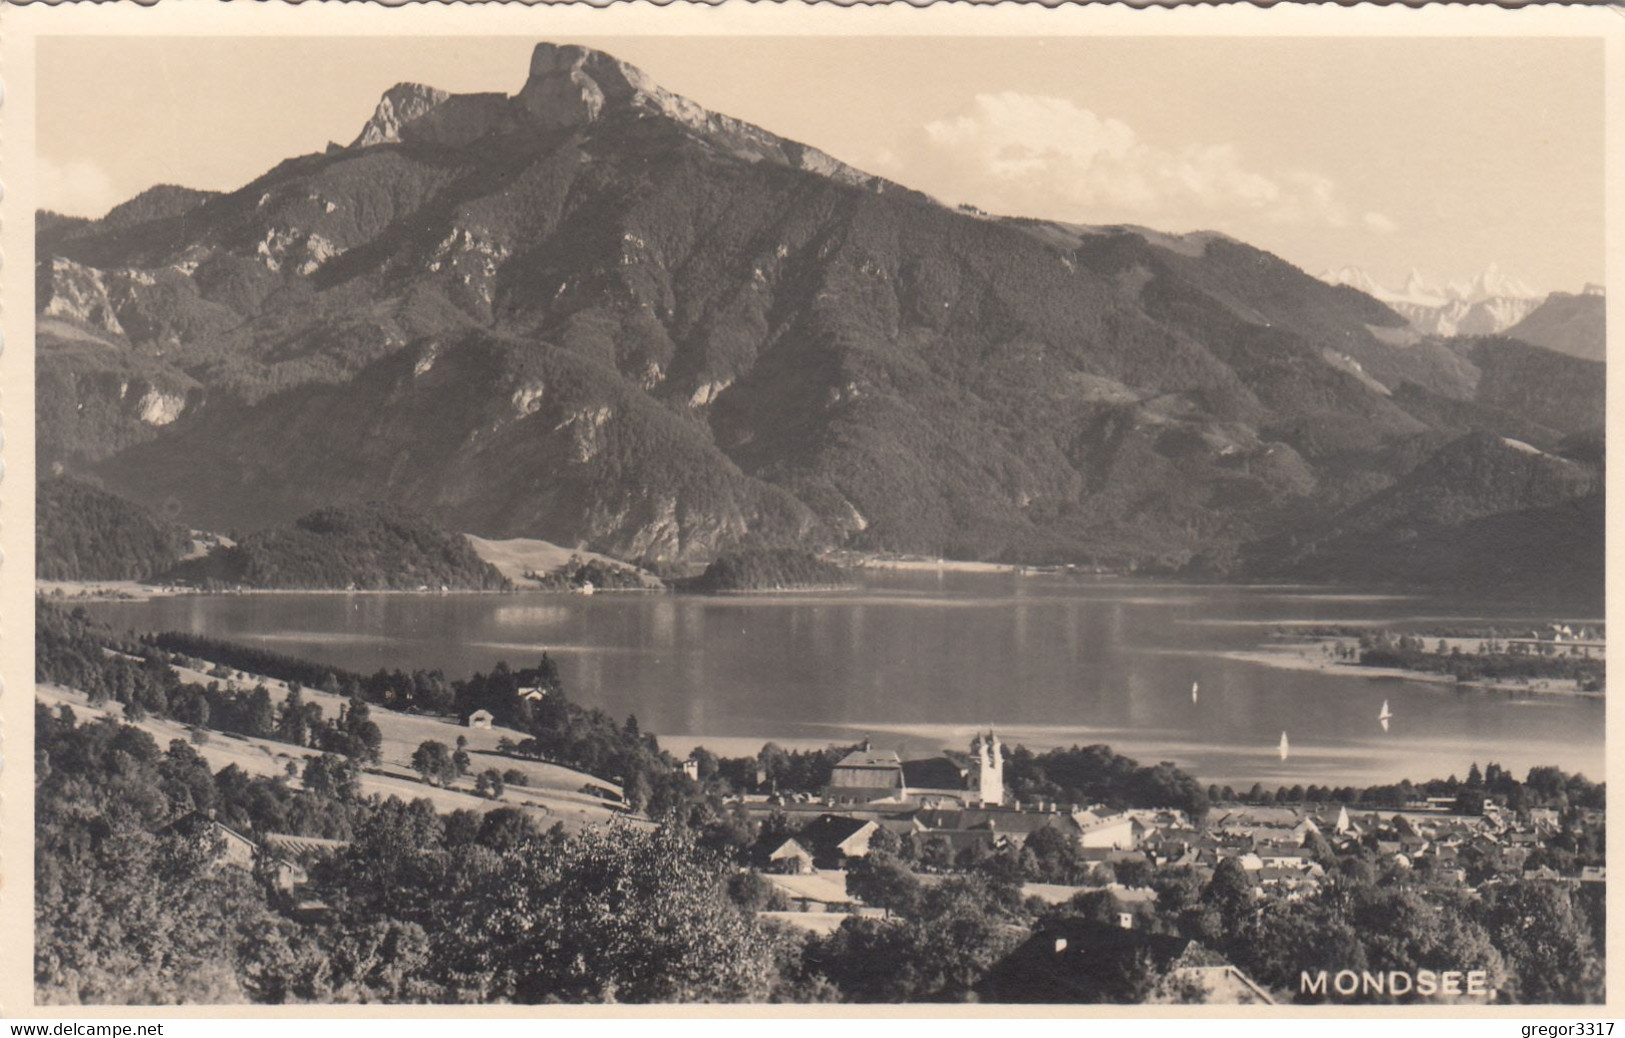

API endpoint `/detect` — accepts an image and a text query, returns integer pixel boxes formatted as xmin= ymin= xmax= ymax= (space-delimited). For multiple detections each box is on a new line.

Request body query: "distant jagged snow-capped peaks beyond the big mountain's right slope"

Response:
xmin=1320 ymin=263 xmax=1544 ymax=335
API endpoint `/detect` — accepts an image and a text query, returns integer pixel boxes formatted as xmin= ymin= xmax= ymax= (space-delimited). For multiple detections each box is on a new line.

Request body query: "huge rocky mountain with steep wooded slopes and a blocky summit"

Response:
xmin=37 ymin=44 xmax=1602 ymax=591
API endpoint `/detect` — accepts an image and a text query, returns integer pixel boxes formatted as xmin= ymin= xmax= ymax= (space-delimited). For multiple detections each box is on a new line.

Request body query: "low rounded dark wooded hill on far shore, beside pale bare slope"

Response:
xmin=171 ymin=504 xmax=509 ymax=591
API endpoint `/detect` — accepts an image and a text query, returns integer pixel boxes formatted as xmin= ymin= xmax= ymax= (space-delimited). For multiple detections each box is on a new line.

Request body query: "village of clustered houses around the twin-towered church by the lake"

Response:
xmin=684 ymin=731 xmax=1606 ymax=1004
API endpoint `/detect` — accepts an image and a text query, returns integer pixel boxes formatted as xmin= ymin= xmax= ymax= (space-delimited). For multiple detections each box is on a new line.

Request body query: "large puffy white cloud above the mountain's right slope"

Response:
xmin=925 ymin=91 xmax=1371 ymax=232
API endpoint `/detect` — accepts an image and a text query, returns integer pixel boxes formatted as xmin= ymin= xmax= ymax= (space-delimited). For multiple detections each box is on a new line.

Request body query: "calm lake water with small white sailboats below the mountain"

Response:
xmin=82 ymin=572 xmax=1604 ymax=786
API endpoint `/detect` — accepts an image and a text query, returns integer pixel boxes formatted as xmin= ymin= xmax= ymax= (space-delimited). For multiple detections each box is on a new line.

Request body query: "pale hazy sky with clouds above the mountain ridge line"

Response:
xmin=36 ymin=36 xmax=1604 ymax=291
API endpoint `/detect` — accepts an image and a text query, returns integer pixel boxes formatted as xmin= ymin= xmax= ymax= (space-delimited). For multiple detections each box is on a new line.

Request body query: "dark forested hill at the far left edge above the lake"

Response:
xmin=34 ymin=478 xmax=192 ymax=580
